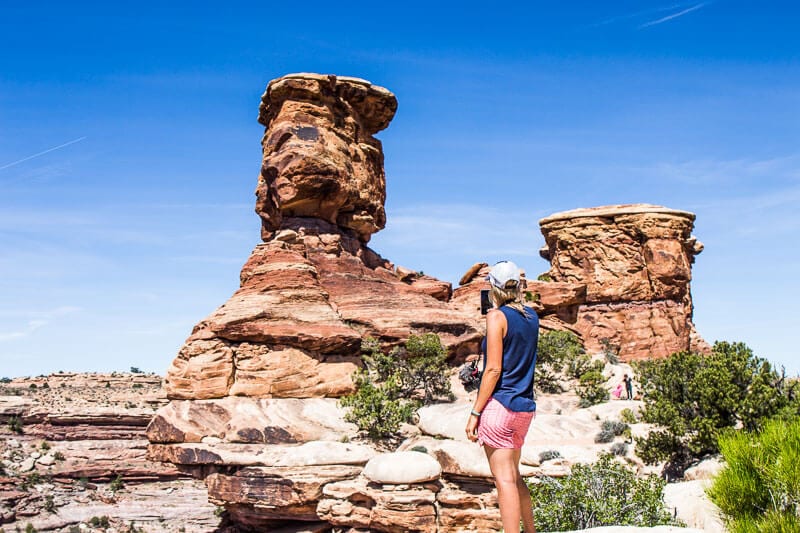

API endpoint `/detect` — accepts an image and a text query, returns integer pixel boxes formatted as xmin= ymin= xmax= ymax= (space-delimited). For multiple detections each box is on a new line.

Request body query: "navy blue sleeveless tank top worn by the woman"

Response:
xmin=483 ymin=306 xmax=539 ymax=412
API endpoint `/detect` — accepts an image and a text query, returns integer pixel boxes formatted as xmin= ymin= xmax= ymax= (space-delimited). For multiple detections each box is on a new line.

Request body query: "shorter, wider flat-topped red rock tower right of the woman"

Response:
xmin=528 ymin=204 xmax=708 ymax=361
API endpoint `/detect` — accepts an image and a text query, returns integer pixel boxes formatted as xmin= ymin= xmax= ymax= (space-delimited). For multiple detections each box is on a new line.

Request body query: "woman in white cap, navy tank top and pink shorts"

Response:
xmin=466 ymin=261 xmax=539 ymax=533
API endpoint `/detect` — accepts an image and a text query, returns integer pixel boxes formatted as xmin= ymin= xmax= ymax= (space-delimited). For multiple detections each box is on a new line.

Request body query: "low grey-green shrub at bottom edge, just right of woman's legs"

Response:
xmin=528 ymin=454 xmax=674 ymax=531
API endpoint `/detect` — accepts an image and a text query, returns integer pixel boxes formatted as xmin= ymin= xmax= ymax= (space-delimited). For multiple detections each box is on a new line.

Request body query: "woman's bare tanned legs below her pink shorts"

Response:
xmin=483 ymin=445 xmax=536 ymax=533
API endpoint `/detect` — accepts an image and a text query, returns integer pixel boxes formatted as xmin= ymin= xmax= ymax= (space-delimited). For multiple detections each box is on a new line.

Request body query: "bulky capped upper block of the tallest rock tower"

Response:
xmin=256 ymin=74 xmax=397 ymax=242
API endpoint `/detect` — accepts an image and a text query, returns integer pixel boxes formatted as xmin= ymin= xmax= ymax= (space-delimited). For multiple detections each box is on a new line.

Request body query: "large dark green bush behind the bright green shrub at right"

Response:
xmin=636 ymin=342 xmax=800 ymax=475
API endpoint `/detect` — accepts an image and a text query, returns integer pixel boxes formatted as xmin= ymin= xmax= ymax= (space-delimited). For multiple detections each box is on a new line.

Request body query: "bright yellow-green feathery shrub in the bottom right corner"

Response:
xmin=708 ymin=418 xmax=800 ymax=533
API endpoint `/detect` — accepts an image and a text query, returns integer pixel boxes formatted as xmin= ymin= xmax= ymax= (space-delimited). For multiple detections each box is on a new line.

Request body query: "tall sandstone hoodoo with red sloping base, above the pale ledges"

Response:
xmin=167 ymin=74 xmax=480 ymax=400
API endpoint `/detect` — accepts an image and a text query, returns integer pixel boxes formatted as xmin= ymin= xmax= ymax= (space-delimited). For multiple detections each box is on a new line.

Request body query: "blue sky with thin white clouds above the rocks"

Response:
xmin=0 ymin=4 xmax=800 ymax=376
